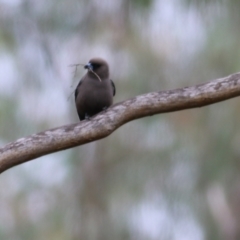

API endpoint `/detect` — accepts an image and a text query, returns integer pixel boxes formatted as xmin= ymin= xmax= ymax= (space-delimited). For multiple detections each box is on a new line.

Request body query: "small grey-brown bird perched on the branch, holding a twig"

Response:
xmin=75 ymin=58 xmax=116 ymax=121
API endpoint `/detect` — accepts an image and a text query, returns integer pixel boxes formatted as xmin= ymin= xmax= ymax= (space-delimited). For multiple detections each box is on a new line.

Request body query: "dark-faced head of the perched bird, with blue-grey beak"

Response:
xmin=84 ymin=58 xmax=109 ymax=81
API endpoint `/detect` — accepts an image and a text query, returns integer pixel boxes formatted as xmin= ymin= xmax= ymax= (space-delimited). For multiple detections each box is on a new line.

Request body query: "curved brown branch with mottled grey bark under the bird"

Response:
xmin=0 ymin=72 xmax=240 ymax=173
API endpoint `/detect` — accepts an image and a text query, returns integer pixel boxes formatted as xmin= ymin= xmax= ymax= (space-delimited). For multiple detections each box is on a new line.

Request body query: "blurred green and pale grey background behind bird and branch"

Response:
xmin=0 ymin=0 xmax=240 ymax=240
